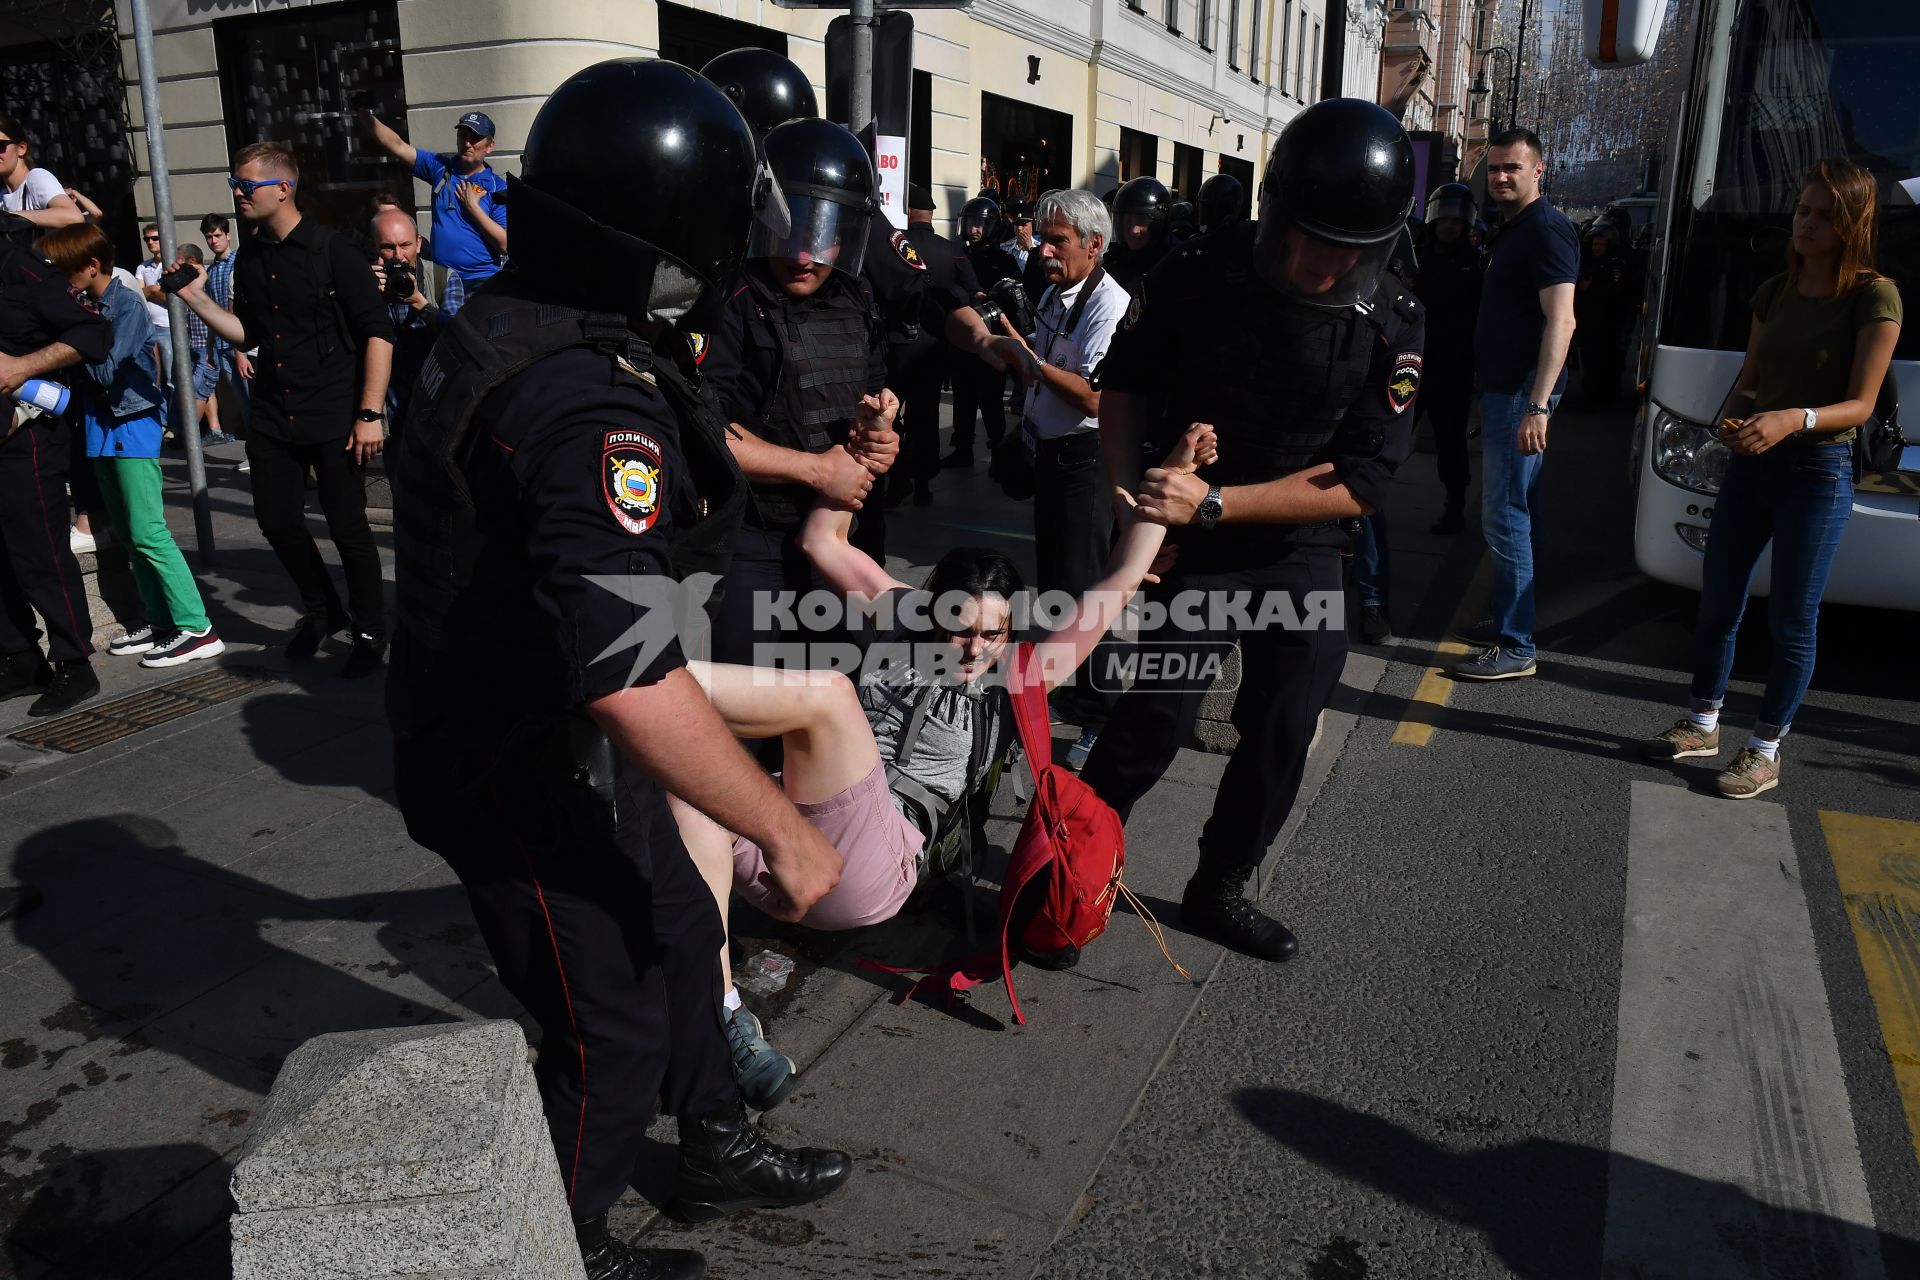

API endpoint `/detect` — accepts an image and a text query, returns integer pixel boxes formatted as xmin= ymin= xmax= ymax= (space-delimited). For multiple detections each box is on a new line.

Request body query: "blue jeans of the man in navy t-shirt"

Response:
xmin=1480 ymin=385 xmax=1559 ymax=658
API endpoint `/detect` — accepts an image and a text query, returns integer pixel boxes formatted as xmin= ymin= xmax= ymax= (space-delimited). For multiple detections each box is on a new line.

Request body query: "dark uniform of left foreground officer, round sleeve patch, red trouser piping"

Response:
xmin=388 ymin=285 xmax=737 ymax=1217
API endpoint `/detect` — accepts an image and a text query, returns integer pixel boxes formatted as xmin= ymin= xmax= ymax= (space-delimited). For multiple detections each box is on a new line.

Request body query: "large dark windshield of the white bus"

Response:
xmin=1661 ymin=0 xmax=1920 ymax=359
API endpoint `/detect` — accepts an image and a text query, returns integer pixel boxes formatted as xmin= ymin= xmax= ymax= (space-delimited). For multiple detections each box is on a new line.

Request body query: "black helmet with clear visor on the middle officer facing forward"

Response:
xmin=747 ymin=119 xmax=879 ymax=276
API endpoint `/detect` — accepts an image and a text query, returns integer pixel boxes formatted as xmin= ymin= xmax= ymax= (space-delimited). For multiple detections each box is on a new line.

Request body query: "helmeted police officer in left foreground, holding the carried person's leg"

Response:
xmin=388 ymin=59 xmax=851 ymax=1280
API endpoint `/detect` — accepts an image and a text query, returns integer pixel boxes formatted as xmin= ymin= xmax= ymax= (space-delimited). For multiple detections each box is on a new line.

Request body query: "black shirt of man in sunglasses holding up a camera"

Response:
xmin=234 ymin=217 xmax=394 ymax=443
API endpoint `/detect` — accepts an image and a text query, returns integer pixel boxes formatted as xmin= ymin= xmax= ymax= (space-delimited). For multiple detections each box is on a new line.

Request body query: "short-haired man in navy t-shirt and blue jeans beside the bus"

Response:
xmin=1453 ymin=129 xmax=1580 ymax=679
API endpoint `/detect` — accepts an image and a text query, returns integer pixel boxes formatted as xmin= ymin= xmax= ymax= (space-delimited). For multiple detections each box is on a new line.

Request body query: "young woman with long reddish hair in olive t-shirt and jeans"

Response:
xmin=1642 ymin=159 xmax=1901 ymax=800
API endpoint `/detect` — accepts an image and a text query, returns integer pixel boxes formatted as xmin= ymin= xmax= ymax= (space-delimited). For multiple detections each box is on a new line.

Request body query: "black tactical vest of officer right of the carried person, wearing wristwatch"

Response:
xmin=1171 ymin=226 xmax=1400 ymax=484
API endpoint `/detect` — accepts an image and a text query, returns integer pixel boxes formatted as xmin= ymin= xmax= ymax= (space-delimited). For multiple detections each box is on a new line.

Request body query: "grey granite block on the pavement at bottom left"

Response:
xmin=232 ymin=1021 xmax=586 ymax=1280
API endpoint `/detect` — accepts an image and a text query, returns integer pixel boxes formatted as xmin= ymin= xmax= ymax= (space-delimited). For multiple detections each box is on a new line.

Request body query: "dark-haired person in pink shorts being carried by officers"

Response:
xmin=672 ymin=422 xmax=1217 ymax=1109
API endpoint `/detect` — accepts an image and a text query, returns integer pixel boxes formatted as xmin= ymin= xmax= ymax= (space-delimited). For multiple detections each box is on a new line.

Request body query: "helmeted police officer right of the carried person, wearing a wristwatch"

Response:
xmin=1083 ymin=98 xmax=1425 ymax=960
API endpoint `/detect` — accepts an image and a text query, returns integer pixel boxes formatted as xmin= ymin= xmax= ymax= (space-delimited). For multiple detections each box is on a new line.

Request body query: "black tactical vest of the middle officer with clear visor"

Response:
xmin=747 ymin=271 xmax=874 ymax=532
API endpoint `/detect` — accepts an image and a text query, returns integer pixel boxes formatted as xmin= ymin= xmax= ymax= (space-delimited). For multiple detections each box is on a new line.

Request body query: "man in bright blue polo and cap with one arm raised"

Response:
xmin=367 ymin=111 xmax=507 ymax=315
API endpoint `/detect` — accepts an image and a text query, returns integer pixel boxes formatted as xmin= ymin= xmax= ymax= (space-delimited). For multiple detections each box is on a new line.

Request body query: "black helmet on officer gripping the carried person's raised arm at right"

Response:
xmin=1256 ymin=98 xmax=1413 ymax=309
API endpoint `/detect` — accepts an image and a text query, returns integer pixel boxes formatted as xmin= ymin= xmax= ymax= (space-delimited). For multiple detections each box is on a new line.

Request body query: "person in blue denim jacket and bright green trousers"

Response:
xmin=36 ymin=223 xmax=227 ymax=666
